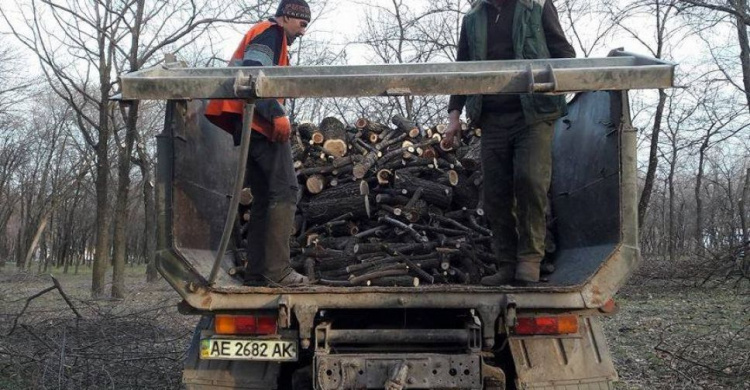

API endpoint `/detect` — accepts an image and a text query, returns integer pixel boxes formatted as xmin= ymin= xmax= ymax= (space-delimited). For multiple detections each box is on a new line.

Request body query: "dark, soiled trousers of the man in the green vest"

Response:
xmin=479 ymin=113 xmax=554 ymax=281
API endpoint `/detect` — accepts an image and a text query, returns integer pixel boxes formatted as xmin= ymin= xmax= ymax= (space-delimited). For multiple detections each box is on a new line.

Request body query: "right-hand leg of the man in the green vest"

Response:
xmin=513 ymin=122 xmax=554 ymax=282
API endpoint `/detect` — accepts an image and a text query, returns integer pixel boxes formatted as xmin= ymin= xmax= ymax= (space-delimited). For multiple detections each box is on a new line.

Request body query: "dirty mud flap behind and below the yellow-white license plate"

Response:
xmin=182 ymin=316 xmax=281 ymax=390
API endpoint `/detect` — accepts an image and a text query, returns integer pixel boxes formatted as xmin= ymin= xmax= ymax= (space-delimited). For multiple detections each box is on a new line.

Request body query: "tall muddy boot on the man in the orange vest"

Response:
xmin=260 ymin=202 xmax=309 ymax=286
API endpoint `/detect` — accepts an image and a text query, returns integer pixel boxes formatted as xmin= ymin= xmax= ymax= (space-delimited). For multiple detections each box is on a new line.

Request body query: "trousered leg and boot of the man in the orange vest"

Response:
xmin=248 ymin=129 xmax=306 ymax=285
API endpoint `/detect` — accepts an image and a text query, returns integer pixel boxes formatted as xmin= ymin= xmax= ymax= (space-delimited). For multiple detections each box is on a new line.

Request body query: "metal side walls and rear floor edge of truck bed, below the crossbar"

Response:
xmin=157 ymin=91 xmax=639 ymax=311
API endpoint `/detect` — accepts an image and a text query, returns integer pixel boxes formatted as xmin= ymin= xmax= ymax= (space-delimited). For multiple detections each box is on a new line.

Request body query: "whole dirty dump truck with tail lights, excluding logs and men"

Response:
xmin=120 ymin=49 xmax=676 ymax=390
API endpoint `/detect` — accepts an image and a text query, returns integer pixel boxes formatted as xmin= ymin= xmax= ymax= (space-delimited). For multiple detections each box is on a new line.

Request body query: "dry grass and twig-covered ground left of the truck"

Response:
xmin=0 ymin=269 xmax=197 ymax=389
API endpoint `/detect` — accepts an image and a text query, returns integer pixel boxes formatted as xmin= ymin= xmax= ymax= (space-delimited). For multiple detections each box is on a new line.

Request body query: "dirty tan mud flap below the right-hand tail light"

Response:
xmin=508 ymin=317 xmax=617 ymax=390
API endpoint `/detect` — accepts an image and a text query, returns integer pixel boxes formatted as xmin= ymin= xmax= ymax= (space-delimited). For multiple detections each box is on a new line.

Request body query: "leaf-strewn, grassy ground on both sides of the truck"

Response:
xmin=0 ymin=266 xmax=750 ymax=390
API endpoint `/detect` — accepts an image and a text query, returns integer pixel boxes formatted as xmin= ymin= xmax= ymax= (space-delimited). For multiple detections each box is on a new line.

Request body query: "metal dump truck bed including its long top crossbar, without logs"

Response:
xmin=116 ymin=51 xmax=674 ymax=311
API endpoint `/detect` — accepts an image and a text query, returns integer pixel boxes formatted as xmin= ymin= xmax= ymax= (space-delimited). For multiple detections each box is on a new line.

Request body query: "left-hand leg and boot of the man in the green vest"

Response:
xmin=482 ymin=116 xmax=518 ymax=286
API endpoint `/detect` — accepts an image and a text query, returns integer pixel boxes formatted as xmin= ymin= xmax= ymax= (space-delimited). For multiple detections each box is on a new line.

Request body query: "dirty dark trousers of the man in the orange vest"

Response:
xmin=245 ymin=131 xmax=299 ymax=281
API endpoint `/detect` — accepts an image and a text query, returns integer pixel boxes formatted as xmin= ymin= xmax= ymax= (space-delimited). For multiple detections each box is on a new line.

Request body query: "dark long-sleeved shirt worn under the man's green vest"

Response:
xmin=448 ymin=0 xmax=576 ymax=113
